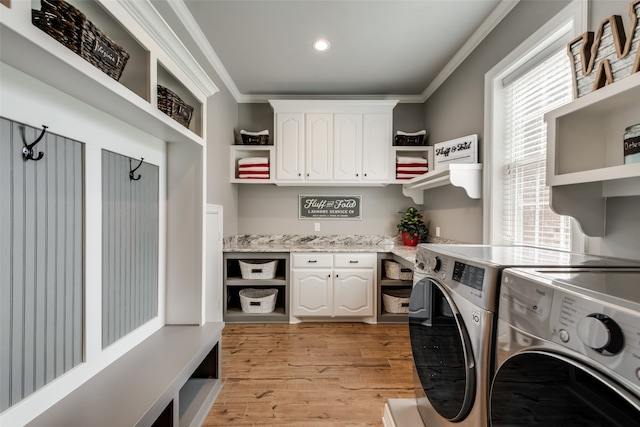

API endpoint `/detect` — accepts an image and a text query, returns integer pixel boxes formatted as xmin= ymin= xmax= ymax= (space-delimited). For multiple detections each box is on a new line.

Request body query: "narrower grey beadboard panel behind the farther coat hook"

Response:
xmin=102 ymin=150 xmax=159 ymax=347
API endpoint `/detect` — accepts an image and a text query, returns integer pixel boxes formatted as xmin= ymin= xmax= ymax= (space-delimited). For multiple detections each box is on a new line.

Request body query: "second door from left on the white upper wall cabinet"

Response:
xmin=305 ymin=114 xmax=333 ymax=181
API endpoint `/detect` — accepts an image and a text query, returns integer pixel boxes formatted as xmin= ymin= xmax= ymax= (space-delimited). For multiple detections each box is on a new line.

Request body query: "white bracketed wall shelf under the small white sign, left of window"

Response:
xmin=402 ymin=163 xmax=482 ymax=205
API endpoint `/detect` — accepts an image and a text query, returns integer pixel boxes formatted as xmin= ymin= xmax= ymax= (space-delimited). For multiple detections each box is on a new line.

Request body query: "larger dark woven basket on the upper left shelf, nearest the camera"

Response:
xmin=31 ymin=0 xmax=129 ymax=80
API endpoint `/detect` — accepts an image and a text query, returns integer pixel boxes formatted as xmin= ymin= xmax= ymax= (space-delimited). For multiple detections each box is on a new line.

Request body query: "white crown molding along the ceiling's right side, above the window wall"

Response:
xmin=421 ymin=0 xmax=520 ymax=102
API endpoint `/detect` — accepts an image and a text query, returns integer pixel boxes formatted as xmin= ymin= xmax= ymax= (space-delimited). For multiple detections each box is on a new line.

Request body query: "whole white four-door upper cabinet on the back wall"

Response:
xmin=269 ymin=100 xmax=397 ymax=185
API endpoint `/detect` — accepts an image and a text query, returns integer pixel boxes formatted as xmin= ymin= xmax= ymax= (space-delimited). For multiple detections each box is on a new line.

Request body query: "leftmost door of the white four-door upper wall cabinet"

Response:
xmin=276 ymin=113 xmax=304 ymax=181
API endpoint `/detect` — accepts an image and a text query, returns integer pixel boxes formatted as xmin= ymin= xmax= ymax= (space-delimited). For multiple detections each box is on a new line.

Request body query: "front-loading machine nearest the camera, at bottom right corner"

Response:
xmin=489 ymin=269 xmax=640 ymax=427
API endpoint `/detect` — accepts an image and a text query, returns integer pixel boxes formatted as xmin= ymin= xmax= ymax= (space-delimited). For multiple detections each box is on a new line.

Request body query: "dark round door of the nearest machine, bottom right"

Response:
xmin=490 ymin=351 xmax=640 ymax=427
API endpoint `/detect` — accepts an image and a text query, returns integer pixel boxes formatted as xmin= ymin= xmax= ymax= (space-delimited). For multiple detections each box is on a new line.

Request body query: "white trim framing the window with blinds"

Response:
xmin=482 ymin=0 xmax=589 ymax=252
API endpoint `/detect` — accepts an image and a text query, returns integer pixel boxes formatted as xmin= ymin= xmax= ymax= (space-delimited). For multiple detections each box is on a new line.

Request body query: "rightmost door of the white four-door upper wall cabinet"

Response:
xmin=362 ymin=113 xmax=392 ymax=181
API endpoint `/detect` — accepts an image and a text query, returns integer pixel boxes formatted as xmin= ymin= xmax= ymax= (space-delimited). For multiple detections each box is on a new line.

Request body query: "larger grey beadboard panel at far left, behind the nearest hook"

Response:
xmin=0 ymin=118 xmax=84 ymax=411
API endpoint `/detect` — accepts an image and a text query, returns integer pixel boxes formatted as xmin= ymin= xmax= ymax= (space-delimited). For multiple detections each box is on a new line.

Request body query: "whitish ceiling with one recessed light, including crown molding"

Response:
xmin=160 ymin=0 xmax=517 ymax=102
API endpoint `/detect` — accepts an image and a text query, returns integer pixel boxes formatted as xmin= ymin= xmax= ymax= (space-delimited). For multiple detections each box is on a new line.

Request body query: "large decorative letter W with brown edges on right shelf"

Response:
xmin=567 ymin=0 xmax=640 ymax=98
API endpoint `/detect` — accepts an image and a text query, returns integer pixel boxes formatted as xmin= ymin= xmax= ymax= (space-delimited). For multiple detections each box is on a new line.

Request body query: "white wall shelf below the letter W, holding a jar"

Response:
xmin=545 ymin=73 xmax=640 ymax=237
